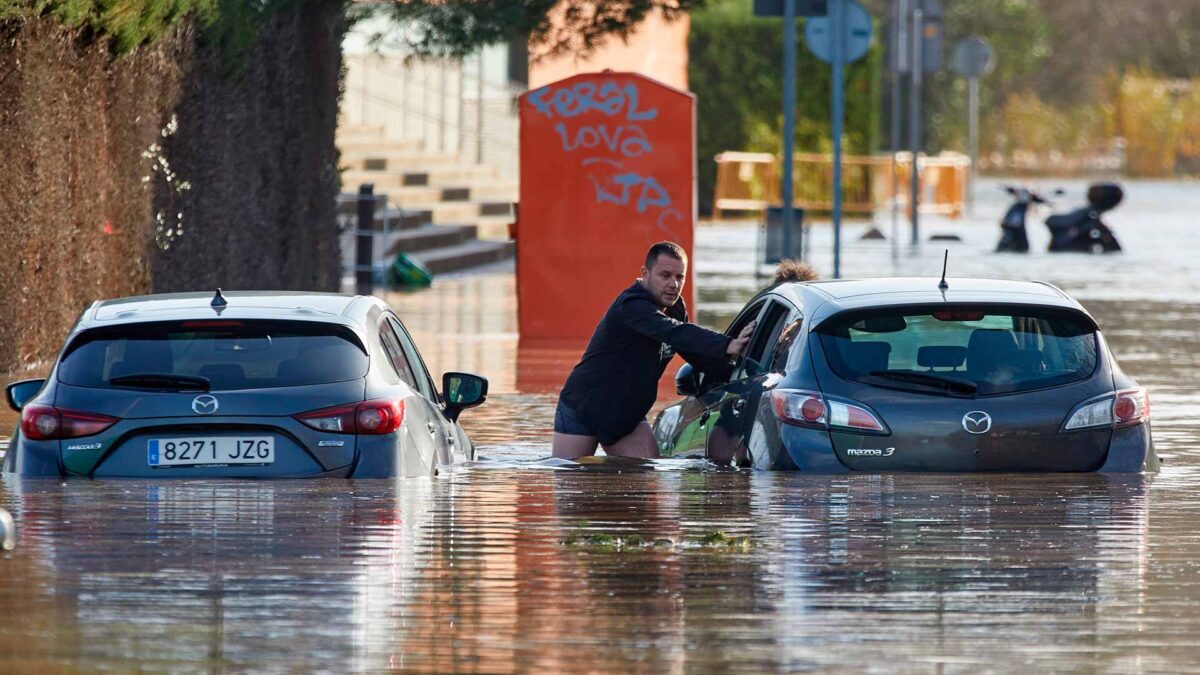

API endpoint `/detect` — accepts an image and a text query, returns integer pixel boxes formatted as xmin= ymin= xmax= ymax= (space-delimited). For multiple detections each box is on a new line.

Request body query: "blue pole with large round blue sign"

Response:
xmin=804 ymin=0 xmax=871 ymax=279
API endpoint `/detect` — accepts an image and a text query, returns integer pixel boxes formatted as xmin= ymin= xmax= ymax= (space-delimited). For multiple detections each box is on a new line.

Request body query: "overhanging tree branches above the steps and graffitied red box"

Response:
xmin=354 ymin=0 xmax=704 ymax=58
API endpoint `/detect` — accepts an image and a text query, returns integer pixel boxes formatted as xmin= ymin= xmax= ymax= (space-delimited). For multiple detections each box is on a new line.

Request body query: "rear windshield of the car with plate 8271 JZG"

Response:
xmin=58 ymin=319 xmax=368 ymax=390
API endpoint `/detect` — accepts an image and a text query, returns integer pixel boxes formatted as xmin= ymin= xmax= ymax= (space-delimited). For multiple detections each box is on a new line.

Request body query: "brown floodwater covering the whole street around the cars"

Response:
xmin=7 ymin=176 xmax=1200 ymax=673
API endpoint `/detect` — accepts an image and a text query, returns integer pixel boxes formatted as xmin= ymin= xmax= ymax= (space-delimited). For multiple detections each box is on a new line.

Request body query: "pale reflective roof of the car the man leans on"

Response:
xmin=770 ymin=276 xmax=1094 ymax=325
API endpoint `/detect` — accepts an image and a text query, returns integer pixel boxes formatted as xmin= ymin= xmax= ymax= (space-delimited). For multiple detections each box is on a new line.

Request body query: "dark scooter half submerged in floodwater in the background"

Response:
xmin=996 ymin=183 xmax=1124 ymax=253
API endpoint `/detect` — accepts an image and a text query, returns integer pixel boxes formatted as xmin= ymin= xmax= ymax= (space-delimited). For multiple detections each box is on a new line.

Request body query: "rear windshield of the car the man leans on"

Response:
xmin=818 ymin=305 xmax=1097 ymax=395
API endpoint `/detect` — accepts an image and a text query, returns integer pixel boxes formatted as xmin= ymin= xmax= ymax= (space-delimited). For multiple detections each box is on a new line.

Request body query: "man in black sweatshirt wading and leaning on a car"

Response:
xmin=553 ymin=241 xmax=754 ymax=459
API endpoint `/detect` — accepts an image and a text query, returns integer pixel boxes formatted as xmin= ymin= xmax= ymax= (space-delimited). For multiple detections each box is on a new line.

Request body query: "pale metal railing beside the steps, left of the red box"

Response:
xmin=342 ymin=54 xmax=524 ymax=180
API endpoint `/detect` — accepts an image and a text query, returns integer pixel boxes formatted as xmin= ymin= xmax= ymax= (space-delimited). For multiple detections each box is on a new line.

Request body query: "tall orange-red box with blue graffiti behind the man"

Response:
xmin=516 ymin=71 xmax=696 ymax=340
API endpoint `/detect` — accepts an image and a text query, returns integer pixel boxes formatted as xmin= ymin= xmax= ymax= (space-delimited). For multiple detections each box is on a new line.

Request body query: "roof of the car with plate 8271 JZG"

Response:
xmin=76 ymin=291 xmax=385 ymax=330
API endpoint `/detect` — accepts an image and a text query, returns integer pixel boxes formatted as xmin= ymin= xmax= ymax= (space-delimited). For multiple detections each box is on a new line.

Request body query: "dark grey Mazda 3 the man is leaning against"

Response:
xmin=654 ymin=279 xmax=1158 ymax=472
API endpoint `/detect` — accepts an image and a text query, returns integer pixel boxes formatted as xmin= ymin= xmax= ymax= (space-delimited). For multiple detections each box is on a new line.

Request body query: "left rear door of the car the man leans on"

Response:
xmin=706 ymin=298 xmax=800 ymax=465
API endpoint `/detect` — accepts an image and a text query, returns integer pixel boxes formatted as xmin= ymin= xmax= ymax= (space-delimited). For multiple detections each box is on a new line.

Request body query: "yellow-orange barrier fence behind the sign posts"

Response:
xmin=713 ymin=153 xmax=971 ymax=217
